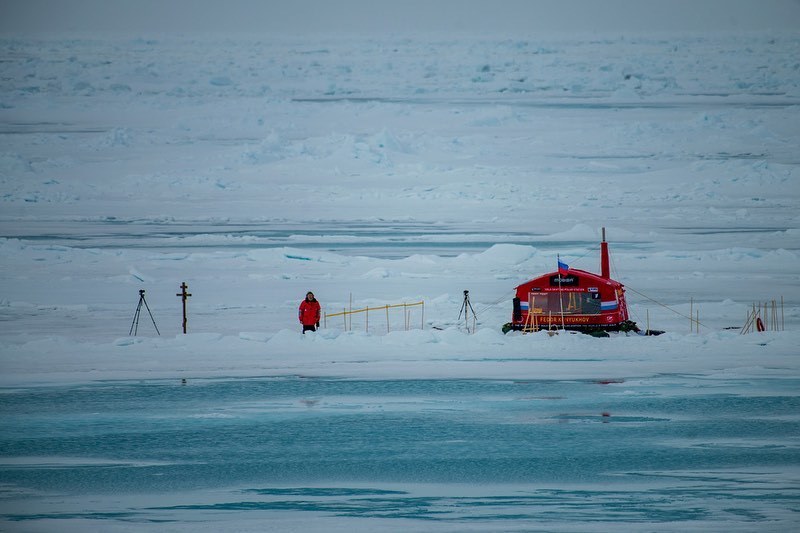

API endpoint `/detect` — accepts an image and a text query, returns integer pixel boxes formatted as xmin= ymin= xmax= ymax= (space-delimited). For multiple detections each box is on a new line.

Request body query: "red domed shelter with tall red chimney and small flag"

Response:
xmin=504 ymin=228 xmax=638 ymax=332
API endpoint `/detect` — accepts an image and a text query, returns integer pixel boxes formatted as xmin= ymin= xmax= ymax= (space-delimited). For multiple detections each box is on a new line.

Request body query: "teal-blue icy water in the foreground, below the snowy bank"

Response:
xmin=0 ymin=375 xmax=800 ymax=531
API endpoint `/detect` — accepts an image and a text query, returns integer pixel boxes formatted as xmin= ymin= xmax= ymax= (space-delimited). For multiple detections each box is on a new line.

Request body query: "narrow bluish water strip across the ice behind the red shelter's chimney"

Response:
xmin=2 ymin=218 xmax=800 ymax=259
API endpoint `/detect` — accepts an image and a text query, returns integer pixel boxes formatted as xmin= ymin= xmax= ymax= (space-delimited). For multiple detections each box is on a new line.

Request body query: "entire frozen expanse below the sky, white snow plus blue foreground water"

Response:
xmin=0 ymin=29 xmax=800 ymax=531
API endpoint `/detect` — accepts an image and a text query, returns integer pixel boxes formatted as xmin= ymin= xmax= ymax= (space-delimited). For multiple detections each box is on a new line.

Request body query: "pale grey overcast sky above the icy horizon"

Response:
xmin=0 ymin=0 xmax=800 ymax=34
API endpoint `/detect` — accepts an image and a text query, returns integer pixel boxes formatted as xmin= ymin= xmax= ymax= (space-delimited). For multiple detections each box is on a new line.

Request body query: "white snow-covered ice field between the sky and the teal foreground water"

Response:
xmin=0 ymin=33 xmax=800 ymax=387
